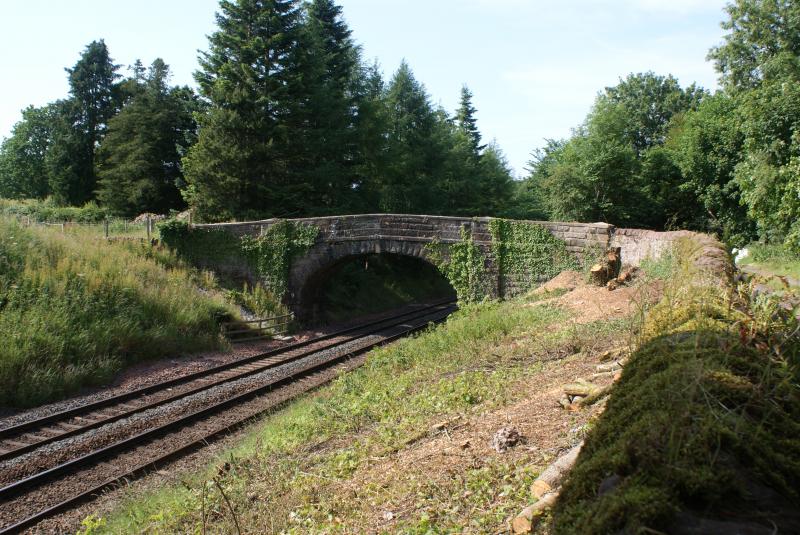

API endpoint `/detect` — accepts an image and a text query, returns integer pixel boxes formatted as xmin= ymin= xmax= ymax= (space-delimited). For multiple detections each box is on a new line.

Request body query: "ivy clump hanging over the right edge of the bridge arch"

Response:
xmin=425 ymin=227 xmax=491 ymax=303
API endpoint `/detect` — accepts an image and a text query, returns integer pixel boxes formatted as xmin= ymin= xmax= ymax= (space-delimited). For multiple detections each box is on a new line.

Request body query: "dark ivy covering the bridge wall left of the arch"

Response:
xmin=159 ymin=220 xmax=319 ymax=296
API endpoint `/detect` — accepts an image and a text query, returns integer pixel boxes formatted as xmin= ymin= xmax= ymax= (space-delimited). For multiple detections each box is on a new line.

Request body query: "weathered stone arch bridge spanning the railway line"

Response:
xmin=194 ymin=214 xmax=614 ymax=319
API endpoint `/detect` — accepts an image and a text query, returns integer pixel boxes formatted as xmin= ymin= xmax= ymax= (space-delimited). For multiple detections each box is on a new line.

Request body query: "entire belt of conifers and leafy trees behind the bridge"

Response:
xmin=0 ymin=0 xmax=800 ymax=248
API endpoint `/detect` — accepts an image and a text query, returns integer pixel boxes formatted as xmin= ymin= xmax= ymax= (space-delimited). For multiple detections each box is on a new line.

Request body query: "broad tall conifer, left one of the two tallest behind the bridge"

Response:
xmin=184 ymin=0 xmax=308 ymax=220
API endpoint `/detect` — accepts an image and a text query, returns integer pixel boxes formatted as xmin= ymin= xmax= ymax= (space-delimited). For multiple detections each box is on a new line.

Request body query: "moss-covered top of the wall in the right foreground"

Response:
xmin=553 ymin=238 xmax=800 ymax=533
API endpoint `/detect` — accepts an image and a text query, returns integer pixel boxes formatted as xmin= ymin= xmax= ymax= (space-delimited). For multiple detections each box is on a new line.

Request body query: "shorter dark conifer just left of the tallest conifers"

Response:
xmin=97 ymin=59 xmax=197 ymax=216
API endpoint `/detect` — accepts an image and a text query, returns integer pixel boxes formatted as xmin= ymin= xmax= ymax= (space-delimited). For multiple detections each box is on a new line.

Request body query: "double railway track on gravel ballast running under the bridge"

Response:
xmin=0 ymin=301 xmax=455 ymax=534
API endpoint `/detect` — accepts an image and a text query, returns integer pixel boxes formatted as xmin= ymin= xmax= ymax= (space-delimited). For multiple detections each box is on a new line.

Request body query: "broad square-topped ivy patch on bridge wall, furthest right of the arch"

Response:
xmin=489 ymin=219 xmax=580 ymax=300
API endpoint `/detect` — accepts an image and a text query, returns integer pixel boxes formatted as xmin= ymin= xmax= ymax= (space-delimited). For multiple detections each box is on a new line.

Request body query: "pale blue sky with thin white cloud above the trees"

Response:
xmin=0 ymin=0 xmax=726 ymax=177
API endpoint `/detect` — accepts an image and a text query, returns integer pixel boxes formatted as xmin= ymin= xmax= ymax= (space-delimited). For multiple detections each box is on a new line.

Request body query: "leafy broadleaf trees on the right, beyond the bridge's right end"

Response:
xmin=515 ymin=0 xmax=800 ymax=249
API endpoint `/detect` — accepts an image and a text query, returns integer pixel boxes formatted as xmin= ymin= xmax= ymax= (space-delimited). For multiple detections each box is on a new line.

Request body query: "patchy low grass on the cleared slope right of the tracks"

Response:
xmin=89 ymin=294 xmax=629 ymax=534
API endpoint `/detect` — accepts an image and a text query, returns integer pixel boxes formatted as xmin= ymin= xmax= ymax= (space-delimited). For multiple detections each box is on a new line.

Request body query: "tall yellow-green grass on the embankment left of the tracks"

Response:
xmin=0 ymin=217 xmax=235 ymax=407
